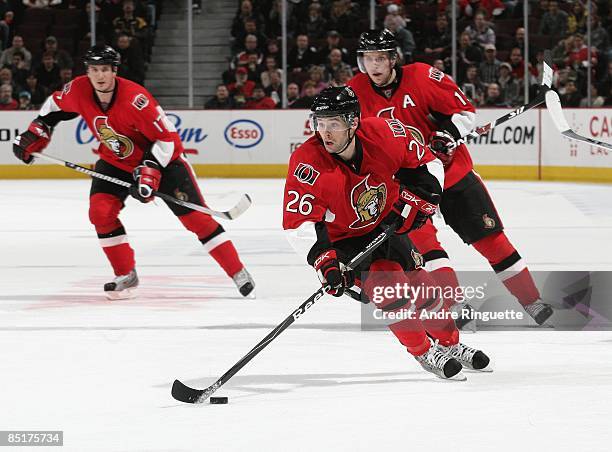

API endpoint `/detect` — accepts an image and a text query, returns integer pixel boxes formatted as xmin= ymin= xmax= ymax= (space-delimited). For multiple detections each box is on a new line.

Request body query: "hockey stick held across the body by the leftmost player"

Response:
xmin=32 ymin=152 xmax=251 ymax=220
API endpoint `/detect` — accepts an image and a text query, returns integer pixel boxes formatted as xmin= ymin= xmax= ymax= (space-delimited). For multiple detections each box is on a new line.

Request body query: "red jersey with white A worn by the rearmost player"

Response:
xmin=348 ymin=63 xmax=475 ymax=189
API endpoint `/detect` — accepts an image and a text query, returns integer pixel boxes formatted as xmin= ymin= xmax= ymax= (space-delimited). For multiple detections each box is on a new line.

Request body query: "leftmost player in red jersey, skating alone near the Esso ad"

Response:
xmin=13 ymin=46 xmax=254 ymax=299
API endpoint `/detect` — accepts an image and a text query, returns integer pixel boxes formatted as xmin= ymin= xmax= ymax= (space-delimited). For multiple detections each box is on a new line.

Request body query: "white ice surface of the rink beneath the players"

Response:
xmin=0 ymin=179 xmax=612 ymax=452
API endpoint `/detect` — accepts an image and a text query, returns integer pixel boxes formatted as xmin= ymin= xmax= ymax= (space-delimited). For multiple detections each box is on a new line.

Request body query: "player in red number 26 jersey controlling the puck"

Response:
xmin=283 ymin=87 xmax=490 ymax=379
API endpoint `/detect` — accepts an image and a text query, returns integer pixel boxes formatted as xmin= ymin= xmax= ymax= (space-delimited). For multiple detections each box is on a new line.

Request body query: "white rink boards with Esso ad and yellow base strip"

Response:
xmin=0 ymin=108 xmax=612 ymax=182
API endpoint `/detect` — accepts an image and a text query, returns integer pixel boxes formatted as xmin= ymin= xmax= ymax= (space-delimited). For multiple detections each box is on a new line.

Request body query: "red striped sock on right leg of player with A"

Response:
xmin=472 ymin=232 xmax=540 ymax=306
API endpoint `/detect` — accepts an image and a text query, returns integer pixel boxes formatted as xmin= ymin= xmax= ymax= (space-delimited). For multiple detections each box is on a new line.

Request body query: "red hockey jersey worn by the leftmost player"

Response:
xmin=40 ymin=76 xmax=183 ymax=172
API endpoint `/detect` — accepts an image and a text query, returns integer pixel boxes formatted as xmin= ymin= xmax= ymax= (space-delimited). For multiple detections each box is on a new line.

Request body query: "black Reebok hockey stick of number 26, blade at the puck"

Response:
xmin=172 ymin=225 xmax=395 ymax=403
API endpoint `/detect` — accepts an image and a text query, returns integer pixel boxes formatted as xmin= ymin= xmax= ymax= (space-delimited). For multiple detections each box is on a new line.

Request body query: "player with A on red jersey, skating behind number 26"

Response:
xmin=348 ymin=30 xmax=553 ymax=325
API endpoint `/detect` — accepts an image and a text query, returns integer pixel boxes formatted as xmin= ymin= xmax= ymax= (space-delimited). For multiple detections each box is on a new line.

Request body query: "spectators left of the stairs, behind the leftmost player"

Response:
xmin=0 ymin=0 xmax=162 ymax=110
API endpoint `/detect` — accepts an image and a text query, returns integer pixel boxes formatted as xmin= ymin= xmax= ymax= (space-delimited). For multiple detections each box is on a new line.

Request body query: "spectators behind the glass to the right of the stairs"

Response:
xmin=205 ymin=0 xmax=612 ymax=108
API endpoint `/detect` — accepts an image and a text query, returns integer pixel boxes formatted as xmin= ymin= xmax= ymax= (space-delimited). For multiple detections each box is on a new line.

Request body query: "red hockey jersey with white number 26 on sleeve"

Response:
xmin=283 ymin=118 xmax=444 ymax=252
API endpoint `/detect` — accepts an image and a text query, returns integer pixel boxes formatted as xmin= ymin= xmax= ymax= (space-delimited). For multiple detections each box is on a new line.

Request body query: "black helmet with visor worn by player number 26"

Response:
xmin=310 ymin=86 xmax=361 ymax=131
